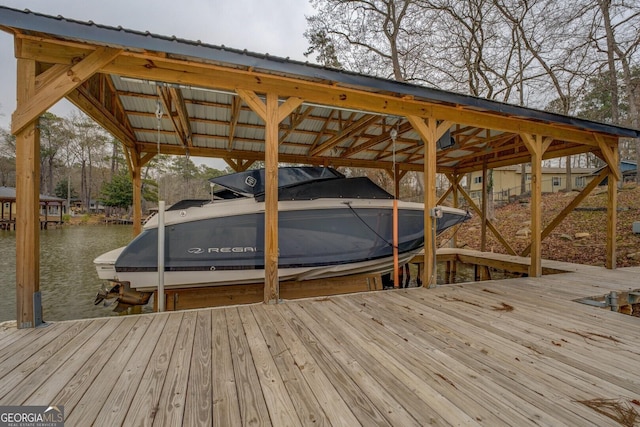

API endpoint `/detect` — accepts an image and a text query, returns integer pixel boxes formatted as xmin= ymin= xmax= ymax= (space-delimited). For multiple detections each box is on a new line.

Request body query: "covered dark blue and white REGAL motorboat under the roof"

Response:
xmin=94 ymin=167 xmax=470 ymax=310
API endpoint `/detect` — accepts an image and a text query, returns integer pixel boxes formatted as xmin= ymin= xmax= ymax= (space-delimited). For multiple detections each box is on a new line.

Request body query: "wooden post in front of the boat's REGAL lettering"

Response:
xmin=264 ymin=93 xmax=280 ymax=304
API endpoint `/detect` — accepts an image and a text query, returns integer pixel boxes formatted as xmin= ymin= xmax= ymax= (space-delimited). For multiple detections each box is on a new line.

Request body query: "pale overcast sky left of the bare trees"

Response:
xmin=0 ymin=0 xmax=314 ymax=166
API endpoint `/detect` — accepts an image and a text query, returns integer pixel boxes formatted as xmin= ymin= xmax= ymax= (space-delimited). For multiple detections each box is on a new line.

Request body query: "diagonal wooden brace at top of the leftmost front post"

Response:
xmin=11 ymin=47 xmax=122 ymax=134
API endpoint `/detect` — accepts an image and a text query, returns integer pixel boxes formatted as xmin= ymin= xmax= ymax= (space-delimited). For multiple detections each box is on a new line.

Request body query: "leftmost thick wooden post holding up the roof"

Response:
xmin=15 ymin=59 xmax=42 ymax=328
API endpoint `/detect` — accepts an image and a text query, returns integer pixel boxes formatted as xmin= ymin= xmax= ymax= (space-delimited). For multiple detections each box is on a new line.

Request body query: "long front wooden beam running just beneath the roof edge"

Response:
xmin=16 ymin=35 xmax=616 ymax=147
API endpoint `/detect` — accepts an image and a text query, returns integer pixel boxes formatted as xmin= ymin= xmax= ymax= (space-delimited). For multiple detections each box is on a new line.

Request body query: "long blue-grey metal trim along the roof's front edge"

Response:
xmin=0 ymin=6 xmax=640 ymax=138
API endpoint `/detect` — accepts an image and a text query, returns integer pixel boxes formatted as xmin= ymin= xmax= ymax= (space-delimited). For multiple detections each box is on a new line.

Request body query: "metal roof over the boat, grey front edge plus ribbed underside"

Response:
xmin=0 ymin=6 xmax=640 ymax=174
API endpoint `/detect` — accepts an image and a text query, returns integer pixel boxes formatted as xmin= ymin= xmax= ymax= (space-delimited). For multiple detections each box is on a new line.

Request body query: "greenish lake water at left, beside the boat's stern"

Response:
xmin=0 ymin=225 xmax=133 ymax=322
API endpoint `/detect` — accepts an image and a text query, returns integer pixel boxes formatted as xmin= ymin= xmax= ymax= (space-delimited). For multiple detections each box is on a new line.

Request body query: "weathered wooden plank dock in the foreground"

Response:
xmin=0 ymin=267 xmax=640 ymax=426
